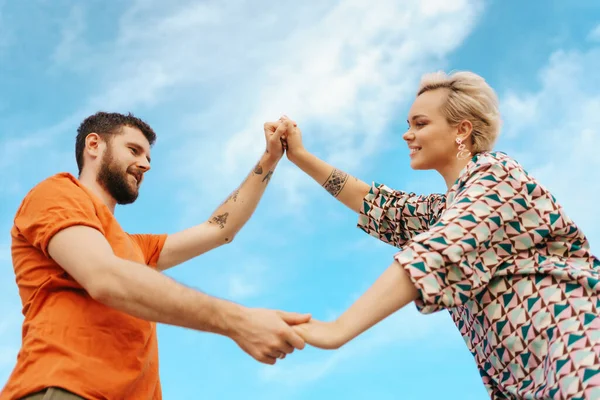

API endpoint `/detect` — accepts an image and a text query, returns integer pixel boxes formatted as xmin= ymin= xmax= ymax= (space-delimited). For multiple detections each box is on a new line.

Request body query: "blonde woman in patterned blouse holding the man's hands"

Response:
xmin=286 ymin=72 xmax=600 ymax=399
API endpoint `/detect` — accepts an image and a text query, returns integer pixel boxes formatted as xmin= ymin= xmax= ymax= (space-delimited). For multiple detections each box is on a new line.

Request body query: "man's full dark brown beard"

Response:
xmin=96 ymin=146 xmax=139 ymax=204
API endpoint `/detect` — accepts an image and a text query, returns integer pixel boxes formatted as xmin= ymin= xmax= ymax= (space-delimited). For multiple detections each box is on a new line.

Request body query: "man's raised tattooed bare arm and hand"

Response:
xmin=157 ymin=121 xmax=292 ymax=270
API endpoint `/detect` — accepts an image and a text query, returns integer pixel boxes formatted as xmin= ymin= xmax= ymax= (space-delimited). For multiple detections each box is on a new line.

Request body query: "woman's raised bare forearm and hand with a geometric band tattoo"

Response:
xmin=286 ymin=122 xmax=371 ymax=213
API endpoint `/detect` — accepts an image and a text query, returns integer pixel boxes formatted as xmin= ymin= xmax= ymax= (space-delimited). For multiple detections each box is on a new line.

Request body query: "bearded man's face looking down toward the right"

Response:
xmin=96 ymin=126 xmax=150 ymax=204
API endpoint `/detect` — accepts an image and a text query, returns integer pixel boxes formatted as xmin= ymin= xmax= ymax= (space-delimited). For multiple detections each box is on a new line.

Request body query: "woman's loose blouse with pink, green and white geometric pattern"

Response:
xmin=358 ymin=152 xmax=600 ymax=400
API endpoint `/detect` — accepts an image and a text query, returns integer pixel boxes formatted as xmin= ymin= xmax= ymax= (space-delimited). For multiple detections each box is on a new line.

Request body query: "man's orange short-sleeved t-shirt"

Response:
xmin=0 ymin=173 xmax=166 ymax=400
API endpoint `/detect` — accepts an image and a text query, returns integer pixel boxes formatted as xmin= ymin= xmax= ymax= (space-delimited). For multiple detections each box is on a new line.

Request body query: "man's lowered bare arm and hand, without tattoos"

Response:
xmin=48 ymin=226 xmax=310 ymax=364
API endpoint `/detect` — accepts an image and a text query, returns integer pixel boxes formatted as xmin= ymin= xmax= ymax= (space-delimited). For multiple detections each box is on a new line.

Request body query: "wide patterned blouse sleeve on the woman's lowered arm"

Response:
xmin=394 ymin=163 xmax=534 ymax=313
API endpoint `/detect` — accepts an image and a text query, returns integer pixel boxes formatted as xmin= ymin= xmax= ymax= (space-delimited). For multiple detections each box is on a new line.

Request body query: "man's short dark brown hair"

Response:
xmin=75 ymin=111 xmax=156 ymax=174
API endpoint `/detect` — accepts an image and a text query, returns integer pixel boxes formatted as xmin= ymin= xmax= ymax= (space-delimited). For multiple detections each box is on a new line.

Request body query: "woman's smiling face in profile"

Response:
xmin=402 ymin=89 xmax=459 ymax=171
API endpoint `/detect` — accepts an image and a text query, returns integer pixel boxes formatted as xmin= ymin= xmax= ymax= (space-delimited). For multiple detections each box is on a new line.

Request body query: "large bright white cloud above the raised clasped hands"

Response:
xmin=218 ymin=1 xmax=480 ymax=179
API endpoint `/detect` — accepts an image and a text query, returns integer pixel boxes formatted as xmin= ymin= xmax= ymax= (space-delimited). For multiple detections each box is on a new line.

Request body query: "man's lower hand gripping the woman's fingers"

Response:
xmin=228 ymin=308 xmax=311 ymax=365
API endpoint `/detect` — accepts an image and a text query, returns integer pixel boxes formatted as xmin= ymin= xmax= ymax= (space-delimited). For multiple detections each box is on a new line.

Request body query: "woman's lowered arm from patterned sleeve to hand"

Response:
xmin=295 ymin=157 xmax=528 ymax=348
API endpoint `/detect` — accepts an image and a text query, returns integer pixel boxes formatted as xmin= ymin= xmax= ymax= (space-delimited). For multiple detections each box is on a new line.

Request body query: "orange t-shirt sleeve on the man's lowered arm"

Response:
xmin=14 ymin=180 xmax=104 ymax=258
